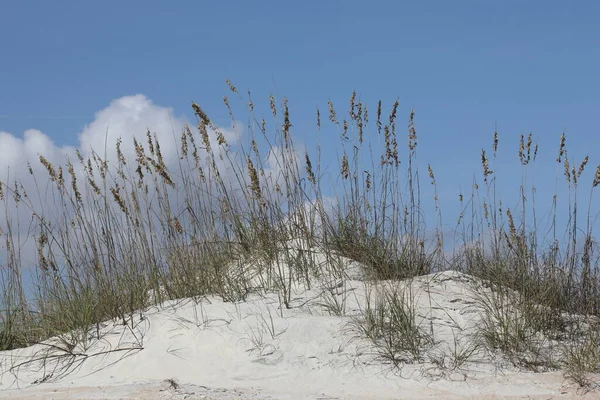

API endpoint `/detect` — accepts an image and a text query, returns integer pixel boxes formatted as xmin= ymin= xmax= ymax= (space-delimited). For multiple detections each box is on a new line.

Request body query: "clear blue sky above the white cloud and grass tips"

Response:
xmin=0 ymin=0 xmax=600 ymax=247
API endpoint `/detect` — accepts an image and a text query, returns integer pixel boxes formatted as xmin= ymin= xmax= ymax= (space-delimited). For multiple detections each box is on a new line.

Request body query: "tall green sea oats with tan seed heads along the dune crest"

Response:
xmin=0 ymin=81 xmax=600 ymax=382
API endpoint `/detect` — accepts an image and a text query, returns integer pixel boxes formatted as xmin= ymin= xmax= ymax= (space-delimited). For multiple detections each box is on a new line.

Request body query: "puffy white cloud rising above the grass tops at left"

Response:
xmin=0 ymin=95 xmax=241 ymax=264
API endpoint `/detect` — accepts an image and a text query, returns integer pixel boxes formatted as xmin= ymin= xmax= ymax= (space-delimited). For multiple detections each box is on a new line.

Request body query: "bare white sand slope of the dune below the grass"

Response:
xmin=0 ymin=248 xmax=600 ymax=400
